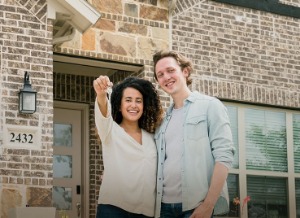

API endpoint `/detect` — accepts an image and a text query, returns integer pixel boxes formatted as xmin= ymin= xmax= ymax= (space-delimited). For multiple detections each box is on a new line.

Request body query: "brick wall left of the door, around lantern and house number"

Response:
xmin=0 ymin=0 xmax=53 ymax=218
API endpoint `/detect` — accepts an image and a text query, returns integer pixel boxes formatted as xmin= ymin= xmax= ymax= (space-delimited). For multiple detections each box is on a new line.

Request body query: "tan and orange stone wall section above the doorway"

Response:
xmin=54 ymin=0 xmax=169 ymax=82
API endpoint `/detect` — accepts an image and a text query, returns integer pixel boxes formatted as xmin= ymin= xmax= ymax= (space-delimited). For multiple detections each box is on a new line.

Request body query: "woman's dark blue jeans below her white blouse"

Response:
xmin=96 ymin=204 xmax=149 ymax=218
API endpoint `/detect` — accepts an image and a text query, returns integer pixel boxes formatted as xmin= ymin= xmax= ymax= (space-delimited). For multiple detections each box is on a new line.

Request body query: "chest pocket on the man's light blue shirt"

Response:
xmin=186 ymin=115 xmax=208 ymax=140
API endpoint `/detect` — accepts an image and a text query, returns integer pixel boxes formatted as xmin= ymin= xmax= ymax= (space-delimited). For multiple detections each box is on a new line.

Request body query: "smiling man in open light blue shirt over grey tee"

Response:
xmin=153 ymin=51 xmax=234 ymax=218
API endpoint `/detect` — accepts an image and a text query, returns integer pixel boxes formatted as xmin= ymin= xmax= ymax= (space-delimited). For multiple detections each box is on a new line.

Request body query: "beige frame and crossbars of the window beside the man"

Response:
xmin=222 ymin=101 xmax=300 ymax=217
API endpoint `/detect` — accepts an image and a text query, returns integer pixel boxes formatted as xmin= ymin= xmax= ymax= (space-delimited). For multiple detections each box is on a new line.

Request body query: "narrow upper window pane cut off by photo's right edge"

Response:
xmin=293 ymin=114 xmax=300 ymax=173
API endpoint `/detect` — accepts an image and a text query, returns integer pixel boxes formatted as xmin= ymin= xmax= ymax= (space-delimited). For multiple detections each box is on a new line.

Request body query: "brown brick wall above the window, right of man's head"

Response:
xmin=172 ymin=0 xmax=300 ymax=108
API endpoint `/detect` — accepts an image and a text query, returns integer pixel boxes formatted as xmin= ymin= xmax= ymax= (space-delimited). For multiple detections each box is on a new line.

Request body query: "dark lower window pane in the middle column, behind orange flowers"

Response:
xmin=247 ymin=176 xmax=288 ymax=218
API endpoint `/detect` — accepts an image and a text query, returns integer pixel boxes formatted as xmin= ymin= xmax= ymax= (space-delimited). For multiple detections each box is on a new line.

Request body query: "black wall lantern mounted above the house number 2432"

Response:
xmin=19 ymin=71 xmax=36 ymax=114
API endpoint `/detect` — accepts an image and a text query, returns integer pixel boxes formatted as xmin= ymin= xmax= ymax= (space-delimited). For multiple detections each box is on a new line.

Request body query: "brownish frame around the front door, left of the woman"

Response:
xmin=53 ymin=100 xmax=90 ymax=217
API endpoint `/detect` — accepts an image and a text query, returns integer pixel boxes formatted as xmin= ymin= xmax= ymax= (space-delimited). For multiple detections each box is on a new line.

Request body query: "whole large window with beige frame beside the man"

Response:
xmin=224 ymin=103 xmax=300 ymax=218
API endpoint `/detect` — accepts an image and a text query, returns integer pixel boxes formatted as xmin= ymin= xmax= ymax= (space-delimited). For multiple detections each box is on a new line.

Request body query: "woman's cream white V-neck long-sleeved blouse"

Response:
xmin=95 ymin=100 xmax=157 ymax=217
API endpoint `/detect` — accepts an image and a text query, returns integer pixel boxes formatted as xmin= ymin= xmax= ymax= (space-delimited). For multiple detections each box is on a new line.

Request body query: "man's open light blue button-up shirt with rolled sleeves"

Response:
xmin=155 ymin=91 xmax=234 ymax=217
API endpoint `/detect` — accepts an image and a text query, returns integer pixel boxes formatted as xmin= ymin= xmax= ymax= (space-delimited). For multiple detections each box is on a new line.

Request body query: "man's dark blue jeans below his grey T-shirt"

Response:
xmin=160 ymin=203 xmax=213 ymax=218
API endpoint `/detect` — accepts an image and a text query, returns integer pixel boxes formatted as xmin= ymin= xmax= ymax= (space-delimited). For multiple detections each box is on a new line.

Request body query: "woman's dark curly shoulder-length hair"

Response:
xmin=110 ymin=77 xmax=163 ymax=133
